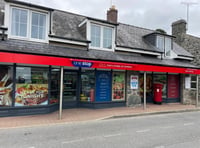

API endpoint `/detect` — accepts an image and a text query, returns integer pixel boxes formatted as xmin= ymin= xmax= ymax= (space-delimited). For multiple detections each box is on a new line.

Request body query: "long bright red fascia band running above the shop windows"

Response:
xmin=0 ymin=52 xmax=200 ymax=74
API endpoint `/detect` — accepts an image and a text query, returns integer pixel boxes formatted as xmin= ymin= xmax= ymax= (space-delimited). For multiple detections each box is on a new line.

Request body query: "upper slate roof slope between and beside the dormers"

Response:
xmin=52 ymin=10 xmax=193 ymax=57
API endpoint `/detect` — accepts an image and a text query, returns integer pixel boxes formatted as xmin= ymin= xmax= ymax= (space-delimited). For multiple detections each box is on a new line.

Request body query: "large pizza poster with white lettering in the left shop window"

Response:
xmin=15 ymin=84 xmax=48 ymax=106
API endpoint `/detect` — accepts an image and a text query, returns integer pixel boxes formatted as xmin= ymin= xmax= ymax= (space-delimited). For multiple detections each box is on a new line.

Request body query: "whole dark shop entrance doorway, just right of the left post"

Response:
xmin=63 ymin=71 xmax=78 ymax=108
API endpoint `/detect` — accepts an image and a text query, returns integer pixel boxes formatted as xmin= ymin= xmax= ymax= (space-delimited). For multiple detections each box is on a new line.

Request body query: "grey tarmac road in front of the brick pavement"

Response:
xmin=0 ymin=112 xmax=200 ymax=148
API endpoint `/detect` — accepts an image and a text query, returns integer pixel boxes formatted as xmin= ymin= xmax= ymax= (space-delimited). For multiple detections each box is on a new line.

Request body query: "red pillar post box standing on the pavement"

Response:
xmin=154 ymin=83 xmax=163 ymax=104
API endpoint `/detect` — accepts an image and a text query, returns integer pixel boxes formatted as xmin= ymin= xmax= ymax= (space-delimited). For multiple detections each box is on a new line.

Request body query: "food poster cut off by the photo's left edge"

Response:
xmin=0 ymin=74 xmax=12 ymax=107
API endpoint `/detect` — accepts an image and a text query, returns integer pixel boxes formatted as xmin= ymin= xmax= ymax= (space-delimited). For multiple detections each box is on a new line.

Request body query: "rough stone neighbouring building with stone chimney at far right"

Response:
xmin=172 ymin=19 xmax=200 ymax=104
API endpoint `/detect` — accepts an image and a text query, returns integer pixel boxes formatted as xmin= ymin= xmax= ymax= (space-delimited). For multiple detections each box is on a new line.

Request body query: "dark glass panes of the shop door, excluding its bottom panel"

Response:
xmin=63 ymin=71 xmax=78 ymax=102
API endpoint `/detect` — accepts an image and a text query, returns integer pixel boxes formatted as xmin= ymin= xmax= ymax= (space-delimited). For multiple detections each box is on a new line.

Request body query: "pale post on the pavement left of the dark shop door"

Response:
xmin=59 ymin=66 xmax=64 ymax=120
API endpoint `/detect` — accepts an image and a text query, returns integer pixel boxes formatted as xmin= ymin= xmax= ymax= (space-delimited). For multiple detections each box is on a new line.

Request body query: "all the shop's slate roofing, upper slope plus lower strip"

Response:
xmin=0 ymin=0 xmax=196 ymax=68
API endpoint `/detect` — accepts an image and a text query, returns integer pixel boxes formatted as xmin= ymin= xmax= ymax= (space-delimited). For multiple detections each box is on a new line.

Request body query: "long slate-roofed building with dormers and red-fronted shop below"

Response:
xmin=0 ymin=0 xmax=200 ymax=116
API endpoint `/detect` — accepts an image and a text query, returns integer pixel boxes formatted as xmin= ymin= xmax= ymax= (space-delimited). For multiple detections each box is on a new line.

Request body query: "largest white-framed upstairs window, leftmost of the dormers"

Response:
xmin=11 ymin=8 xmax=47 ymax=40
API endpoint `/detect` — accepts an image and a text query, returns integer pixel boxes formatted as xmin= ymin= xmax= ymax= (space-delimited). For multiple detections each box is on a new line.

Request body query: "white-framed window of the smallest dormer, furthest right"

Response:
xmin=156 ymin=35 xmax=172 ymax=57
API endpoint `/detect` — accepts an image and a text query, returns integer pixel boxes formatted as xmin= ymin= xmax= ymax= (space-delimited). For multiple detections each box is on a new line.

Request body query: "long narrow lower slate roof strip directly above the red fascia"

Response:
xmin=0 ymin=39 xmax=197 ymax=68
